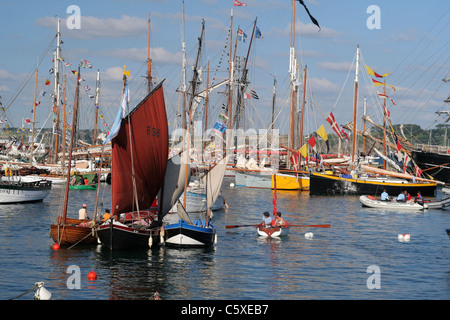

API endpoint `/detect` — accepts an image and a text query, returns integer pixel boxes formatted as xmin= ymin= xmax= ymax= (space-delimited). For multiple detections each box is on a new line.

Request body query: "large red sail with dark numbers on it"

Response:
xmin=111 ymin=84 xmax=169 ymax=214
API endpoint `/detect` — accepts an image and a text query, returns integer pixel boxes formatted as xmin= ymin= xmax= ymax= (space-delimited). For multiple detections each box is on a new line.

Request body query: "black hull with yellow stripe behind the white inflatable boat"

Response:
xmin=309 ymin=173 xmax=436 ymax=197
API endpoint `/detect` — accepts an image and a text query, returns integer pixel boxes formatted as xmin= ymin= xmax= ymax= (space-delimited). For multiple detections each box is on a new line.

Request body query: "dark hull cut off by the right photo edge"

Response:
xmin=412 ymin=151 xmax=450 ymax=184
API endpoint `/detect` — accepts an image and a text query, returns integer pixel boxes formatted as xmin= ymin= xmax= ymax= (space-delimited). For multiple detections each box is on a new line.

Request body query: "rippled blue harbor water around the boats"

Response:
xmin=0 ymin=177 xmax=450 ymax=300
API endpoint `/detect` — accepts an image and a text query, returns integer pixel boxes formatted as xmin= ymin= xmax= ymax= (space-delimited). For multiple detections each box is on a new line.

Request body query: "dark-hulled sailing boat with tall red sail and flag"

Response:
xmin=97 ymin=72 xmax=169 ymax=249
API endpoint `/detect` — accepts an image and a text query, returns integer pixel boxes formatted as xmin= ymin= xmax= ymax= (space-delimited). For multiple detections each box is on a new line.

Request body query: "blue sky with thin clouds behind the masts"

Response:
xmin=0 ymin=0 xmax=450 ymax=139
